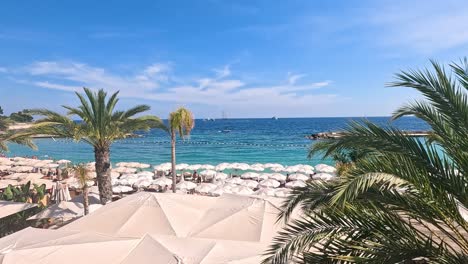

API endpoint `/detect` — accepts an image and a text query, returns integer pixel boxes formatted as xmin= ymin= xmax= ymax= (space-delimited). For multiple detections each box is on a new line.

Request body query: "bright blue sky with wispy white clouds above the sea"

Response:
xmin=0 ymin=0 xmax=468 ymax=118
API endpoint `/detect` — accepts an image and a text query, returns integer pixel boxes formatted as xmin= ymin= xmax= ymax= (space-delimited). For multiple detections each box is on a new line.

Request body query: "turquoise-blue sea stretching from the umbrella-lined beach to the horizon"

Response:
xmin=7 ymin=117 xmax=429 ymax=165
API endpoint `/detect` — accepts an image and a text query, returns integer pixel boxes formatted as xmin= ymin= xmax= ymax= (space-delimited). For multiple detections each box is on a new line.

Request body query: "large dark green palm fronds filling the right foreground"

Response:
xmin=264 ymin=59 xmax=468 ymax=263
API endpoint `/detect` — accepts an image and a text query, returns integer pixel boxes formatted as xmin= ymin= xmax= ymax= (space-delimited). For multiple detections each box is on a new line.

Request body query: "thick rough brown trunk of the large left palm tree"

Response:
xmin=94 ymin=147 xmax=112 ymax=204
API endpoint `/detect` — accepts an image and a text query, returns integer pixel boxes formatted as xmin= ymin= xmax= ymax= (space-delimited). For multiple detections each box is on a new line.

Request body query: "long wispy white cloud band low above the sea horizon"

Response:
xmin=14 ymin=61 xmax=338 ymax=115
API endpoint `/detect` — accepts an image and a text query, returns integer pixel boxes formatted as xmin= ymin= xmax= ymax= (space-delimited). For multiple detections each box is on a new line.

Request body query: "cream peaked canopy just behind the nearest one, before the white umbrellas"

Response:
xmin=61 ymin=191 xmax=288 ymax=242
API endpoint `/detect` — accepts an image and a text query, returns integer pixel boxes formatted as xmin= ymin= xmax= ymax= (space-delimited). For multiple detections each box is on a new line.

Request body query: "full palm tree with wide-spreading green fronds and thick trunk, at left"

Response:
xmin=30 ymin=88 xmax=163 ymax=204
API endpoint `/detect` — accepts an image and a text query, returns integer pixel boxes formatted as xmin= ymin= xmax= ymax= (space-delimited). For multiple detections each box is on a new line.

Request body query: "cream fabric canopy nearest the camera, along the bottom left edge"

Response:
xmin=0 ymin=228 xmax=268 ymax=264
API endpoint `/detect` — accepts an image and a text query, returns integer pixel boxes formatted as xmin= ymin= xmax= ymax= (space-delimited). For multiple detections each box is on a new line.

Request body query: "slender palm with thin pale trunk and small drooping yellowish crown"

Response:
xmin=166 ymin=107 xmax=195 ymax=192
